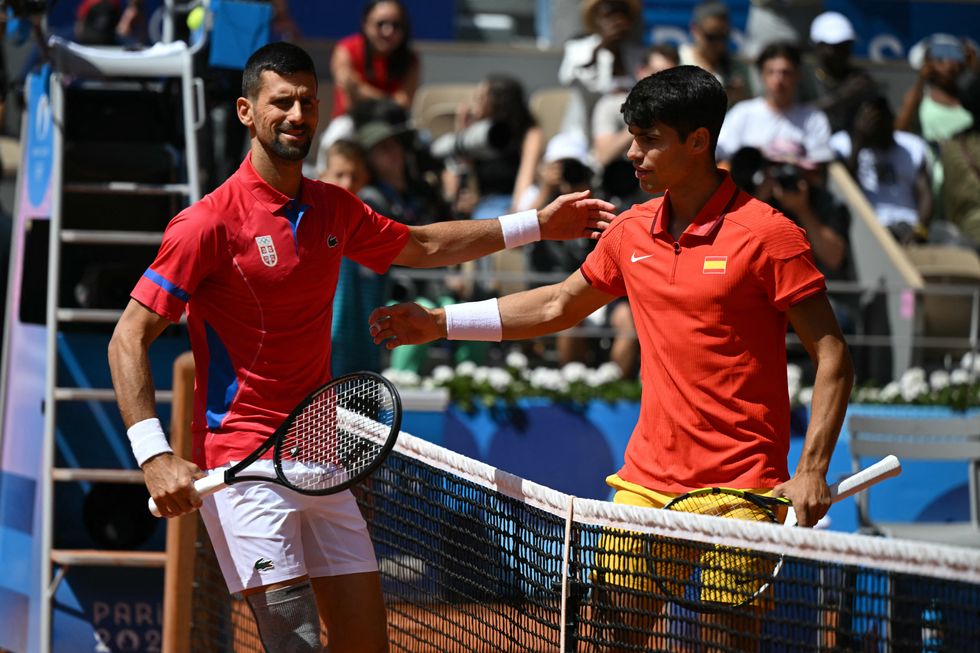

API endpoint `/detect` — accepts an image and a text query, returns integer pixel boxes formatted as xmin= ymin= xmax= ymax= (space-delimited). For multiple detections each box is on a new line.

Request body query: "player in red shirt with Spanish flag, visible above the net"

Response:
xmin=371 ymin=66 xmax=853 ymax=648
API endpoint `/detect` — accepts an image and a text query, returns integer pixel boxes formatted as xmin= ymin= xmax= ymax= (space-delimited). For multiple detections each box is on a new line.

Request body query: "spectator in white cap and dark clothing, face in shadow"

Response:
xmin=800 ymin=11 xmax=878 ymax=132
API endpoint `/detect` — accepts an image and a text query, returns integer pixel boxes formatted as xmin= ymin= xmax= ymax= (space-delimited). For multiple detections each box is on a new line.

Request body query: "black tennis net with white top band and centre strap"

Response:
xmin=176 ymin=433 xmax=980 ymax=653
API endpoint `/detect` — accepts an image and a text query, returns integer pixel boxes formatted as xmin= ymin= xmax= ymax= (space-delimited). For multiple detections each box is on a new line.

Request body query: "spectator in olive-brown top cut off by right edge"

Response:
xmin=940 ymin=77 xmax=980 ymax=249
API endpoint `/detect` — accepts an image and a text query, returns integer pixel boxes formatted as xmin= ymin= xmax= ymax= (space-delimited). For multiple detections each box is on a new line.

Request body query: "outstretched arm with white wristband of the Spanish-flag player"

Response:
xmin=368 ymin=271 xmax=615 ymax=349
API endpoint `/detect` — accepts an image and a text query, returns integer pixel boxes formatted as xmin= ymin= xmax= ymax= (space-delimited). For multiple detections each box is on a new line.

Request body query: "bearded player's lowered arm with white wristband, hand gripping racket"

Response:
xmin=109 ymin=300 xmax=203 ymax=517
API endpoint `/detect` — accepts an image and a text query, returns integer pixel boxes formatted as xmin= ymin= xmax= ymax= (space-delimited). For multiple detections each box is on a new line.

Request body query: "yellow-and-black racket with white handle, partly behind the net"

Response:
xmin=650 ymin=456 xmax=902 ymax=612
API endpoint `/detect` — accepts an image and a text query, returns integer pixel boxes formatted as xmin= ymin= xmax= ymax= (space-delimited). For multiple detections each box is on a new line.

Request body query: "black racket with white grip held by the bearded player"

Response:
xmin=149 ymin=372 xmax=402 ymax=517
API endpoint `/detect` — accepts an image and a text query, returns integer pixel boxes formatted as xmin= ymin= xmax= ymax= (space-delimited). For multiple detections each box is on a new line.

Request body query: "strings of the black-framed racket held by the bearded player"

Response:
xmin=280 ymin=379 xmax=395 ymax=491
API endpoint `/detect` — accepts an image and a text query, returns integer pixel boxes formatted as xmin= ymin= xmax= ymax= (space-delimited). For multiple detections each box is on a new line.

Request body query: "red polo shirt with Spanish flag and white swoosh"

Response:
xmin=581 ymin=173 xmax=825 ymax=492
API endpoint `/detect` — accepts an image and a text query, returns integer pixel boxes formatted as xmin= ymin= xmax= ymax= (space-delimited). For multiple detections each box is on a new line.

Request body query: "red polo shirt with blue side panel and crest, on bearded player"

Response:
xmin=132 ymin=155 xmax=408 ymax=469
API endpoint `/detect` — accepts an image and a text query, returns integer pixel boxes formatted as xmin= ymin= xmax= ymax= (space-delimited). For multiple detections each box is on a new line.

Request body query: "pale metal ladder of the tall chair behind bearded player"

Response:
xmin=38 ymin=19 xmax=204 ymax=653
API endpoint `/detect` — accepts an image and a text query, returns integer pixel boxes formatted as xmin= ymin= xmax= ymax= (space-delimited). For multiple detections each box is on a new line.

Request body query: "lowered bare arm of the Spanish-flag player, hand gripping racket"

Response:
xmin=773 ymin=293 xmax=854 ymax=526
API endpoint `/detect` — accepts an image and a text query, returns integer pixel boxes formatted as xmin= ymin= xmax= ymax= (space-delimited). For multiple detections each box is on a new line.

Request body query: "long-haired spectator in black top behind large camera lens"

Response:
xmin=443 ymin=75 xmax=544 ymax=219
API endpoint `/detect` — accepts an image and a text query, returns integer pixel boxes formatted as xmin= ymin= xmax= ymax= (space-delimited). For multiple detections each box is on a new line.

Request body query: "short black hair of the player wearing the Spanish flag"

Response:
xmin=622 ymin=66 xmax=728 ymax=156
